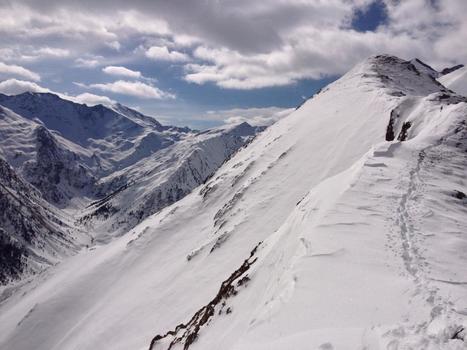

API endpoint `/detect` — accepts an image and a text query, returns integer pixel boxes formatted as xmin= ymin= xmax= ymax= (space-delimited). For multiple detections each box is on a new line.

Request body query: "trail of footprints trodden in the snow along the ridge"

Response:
xmin=384 ymin=138 xmax=467 ymax=349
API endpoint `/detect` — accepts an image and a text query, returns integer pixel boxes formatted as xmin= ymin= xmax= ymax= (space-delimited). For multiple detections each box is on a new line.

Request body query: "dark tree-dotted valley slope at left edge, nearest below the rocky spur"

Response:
xmin=0 ymin=158 xmax=85 ymax=286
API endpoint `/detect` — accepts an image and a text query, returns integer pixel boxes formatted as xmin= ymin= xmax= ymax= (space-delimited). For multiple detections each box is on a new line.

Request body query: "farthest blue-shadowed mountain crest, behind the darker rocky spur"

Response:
xmin=0 ymin=93 xmax=190 ymax=176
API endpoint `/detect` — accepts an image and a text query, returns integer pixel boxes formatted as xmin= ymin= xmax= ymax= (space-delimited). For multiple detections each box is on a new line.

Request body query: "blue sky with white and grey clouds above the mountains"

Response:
xmin=0 ymin=0 xmax=467 ymax=129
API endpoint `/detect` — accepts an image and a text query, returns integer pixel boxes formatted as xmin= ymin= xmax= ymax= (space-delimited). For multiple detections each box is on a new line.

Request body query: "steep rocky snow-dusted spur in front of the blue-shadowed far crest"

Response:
xmin=0 ymin=106 xmax=96 ymax=206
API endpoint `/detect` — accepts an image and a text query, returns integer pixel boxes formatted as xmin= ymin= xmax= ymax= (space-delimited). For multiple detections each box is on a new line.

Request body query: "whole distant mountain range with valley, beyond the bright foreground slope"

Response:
xmin=0 ymin=93 xmax=259 ymax=284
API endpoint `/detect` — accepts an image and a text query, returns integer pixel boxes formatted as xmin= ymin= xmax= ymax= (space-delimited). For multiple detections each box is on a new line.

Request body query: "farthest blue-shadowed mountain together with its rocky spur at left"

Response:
xmin=0 ymin=93 xmax=191 ymax=206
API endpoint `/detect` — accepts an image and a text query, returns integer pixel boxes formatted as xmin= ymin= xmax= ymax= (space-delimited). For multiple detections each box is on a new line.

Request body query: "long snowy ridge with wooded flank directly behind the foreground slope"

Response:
xmin=79 ymin=123 xmax=258 ymax=234
